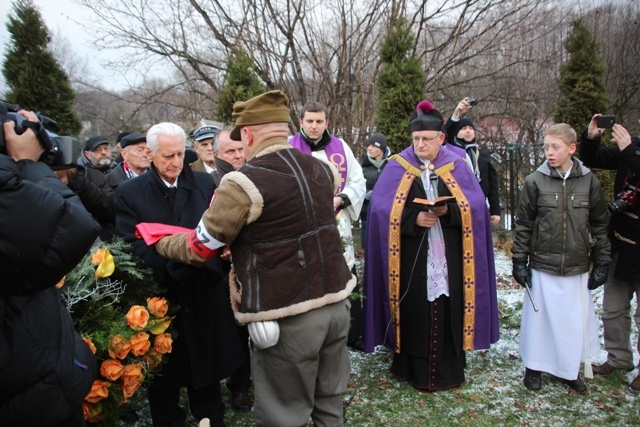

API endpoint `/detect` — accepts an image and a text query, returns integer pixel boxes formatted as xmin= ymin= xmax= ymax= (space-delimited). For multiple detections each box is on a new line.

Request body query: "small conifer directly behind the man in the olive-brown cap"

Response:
xmin=216 ymin=46 xmax=265 ymax=124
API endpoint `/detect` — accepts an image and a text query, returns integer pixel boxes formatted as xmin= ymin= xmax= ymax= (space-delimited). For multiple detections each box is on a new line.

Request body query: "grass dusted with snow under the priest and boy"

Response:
xmin=117 ymin=250 xmax=640 ymax=427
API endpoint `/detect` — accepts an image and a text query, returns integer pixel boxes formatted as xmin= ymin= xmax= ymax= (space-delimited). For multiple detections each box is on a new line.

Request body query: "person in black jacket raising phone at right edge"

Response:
xmin=580 ymin=114 xmax=640 ymax=392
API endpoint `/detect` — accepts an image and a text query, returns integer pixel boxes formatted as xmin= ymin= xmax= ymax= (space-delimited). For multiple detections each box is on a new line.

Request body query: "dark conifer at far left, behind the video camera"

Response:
xmin=2 ymin=0 xmax=81 ymax=136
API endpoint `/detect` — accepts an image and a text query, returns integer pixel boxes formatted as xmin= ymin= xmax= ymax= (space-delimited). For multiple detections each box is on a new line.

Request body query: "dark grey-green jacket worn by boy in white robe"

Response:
xmin=512 ymin=158 xmax=611 ymax=276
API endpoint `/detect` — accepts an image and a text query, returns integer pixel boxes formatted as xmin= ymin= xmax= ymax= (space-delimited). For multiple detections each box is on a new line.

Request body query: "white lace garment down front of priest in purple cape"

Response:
xmin=420 ymin=160 xmax=449 ymax=301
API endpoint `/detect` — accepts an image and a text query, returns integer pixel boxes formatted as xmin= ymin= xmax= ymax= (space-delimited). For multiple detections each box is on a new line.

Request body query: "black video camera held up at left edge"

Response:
xmin=0 ymin=100 xmax=78 ymax=169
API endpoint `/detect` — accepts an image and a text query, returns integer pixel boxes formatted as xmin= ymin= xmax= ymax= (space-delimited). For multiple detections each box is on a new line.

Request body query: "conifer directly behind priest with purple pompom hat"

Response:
xmin=375 ymin=19 xmax=426 ymax=153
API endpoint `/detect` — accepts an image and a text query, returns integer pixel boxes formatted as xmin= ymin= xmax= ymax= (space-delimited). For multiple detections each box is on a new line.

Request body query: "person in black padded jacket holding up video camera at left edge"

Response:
xmin=0 ymin=110 xmax=99 ymax=426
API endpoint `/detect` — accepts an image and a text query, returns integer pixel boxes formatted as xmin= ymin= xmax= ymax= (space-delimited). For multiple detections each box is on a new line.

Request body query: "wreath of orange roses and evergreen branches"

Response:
xmin=59 ymin=239 xmax=178 ymax=425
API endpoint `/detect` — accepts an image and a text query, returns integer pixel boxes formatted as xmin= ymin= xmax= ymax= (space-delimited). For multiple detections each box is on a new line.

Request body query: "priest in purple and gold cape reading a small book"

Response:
xmin=364 ymin=101 xmax=499 ymax=391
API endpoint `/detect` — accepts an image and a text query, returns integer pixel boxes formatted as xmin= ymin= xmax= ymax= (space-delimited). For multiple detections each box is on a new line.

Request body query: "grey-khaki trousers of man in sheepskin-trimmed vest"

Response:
xmin=251 ymin=300 xmax=351 ymax=427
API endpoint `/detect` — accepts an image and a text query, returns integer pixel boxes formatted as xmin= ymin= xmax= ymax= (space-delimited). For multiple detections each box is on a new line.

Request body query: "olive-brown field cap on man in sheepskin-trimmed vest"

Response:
xmin=230 ymin=90 xmax=291 ymax=141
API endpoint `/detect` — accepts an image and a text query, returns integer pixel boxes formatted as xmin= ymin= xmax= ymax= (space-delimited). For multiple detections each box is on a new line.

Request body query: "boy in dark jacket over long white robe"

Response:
xmin=512 ymin=123 xmax=611 ymax=393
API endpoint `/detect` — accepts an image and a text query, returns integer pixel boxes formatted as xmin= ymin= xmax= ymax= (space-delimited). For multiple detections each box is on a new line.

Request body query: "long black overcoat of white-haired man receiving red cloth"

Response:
xmin=115 ymin=165 xmax=244 ymax=388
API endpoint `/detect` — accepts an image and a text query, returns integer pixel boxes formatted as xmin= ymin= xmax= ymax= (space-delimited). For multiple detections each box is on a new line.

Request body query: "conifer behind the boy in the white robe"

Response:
xmin=553 ymin=19 xmax=608 ymax=133
